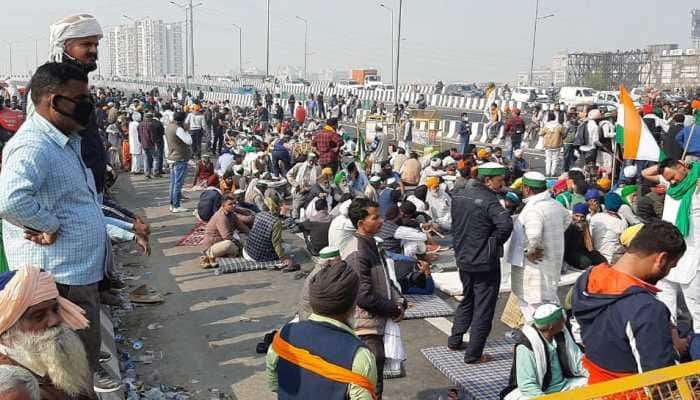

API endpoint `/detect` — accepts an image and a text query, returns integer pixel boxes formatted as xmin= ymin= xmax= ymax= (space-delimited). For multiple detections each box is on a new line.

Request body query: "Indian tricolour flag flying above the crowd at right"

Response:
xmin=615 ymin=85 xmax=664 ymax=162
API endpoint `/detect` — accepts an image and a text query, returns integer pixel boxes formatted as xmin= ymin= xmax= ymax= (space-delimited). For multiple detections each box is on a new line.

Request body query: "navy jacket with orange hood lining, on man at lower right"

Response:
xmin=573 ymin=264 xmax=677 ymax=378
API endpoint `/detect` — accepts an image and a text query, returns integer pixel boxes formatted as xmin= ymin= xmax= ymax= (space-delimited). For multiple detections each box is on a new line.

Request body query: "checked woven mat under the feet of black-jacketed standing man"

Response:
xmin=421 ymin=338 xmax=514 ymax=400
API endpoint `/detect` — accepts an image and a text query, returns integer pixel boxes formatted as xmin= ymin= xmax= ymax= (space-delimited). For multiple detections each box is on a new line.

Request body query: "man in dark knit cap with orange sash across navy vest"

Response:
xmin=266 ymin=258 xmax=377 ymax=400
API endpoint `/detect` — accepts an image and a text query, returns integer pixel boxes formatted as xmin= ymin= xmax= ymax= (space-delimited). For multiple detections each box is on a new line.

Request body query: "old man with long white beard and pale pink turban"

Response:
xmin=0 ymin=266 xmax=94 ymax=400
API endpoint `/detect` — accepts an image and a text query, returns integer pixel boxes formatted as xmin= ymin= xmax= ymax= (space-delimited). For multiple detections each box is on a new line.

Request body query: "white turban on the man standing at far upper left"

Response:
xmin=49 ymin=14 xmax=102 ymax=62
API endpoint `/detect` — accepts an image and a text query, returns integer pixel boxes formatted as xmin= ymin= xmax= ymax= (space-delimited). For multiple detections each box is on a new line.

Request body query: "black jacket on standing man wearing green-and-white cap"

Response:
xmin=452 ymin=182 xmax=513 ymax=272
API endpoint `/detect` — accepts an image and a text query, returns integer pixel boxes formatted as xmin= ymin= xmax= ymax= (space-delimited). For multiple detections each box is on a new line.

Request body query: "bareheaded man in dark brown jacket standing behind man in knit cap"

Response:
xmin=341 ymin=198 xmax=406 ymax=400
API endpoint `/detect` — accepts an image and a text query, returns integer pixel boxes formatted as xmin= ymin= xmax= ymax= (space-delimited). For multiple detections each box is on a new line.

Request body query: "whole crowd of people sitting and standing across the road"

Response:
xmin=0 ymin=10 xmax=700 ymax=399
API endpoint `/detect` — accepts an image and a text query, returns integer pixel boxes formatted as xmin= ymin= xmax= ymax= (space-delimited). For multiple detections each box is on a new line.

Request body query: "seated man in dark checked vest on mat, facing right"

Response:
xmin=243 ymin=196 xmax=299 ymax=272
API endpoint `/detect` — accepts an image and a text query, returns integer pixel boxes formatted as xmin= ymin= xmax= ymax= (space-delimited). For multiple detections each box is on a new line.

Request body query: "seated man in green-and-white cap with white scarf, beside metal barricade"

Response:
xmin=501 ymin=304 xmax=588 ymax=400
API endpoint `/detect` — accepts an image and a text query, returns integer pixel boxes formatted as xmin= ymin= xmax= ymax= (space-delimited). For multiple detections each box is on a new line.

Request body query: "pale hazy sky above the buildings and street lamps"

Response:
xmin=0 ymin=0 xmax=700 ymax=81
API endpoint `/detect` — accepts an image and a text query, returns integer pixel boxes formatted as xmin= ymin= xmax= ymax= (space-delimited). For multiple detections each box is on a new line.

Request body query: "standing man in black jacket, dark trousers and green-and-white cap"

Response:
xmin=447 ymin=162 xmax=513 ymax=363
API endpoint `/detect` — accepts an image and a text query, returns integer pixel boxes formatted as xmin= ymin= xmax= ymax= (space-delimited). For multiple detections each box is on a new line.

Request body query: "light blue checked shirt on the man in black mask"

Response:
xmin=0 ymin=113 xmax=107 ymax=286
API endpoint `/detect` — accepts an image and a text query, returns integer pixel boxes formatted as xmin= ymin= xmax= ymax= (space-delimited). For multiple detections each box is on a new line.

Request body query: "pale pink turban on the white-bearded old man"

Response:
xmin=0 ymin=266 xmax=89 ymax=334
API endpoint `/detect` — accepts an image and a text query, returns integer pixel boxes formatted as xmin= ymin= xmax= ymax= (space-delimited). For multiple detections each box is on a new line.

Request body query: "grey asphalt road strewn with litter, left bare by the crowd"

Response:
xmin=114 ymin=163 xmax=560 ymax=400
